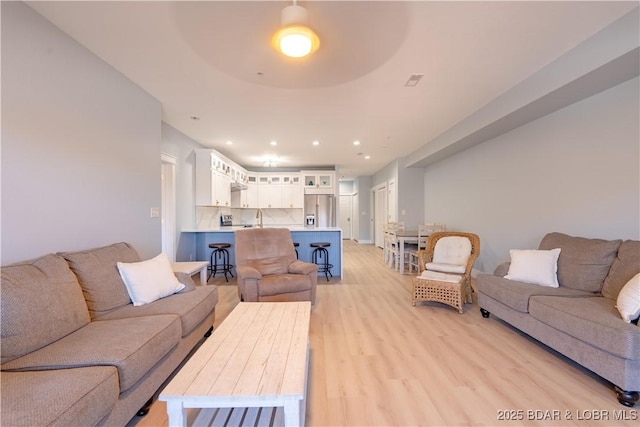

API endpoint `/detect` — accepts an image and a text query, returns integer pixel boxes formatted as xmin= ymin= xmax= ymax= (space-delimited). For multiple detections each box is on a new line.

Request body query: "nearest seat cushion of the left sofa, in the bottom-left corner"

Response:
xmin=0 ymin=366 xmax=118 ymax=426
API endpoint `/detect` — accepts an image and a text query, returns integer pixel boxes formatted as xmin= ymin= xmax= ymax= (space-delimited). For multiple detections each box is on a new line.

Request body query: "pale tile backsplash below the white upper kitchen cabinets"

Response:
xmin=196 ymin=206 xmax=303 ymax=230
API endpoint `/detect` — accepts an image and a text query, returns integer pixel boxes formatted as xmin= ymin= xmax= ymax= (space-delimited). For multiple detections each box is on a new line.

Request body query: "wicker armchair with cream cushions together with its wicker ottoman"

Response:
xmin=412 ymin=231 xmax=480 ymax=313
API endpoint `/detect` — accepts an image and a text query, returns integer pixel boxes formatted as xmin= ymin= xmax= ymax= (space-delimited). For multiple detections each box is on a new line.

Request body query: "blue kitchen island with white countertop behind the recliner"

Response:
xmin=182 ymin=225 xmax=342 ymax=277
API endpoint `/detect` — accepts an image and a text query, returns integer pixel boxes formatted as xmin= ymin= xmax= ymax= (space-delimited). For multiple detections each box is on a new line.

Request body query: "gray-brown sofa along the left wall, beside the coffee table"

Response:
xmin=0 ymin=243 xmax=218 ymax=426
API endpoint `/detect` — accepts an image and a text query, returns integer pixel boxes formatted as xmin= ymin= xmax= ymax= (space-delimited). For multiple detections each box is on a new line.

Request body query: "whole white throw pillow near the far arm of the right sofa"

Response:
xmin=504 ymin=248 xmax=560 ymax=288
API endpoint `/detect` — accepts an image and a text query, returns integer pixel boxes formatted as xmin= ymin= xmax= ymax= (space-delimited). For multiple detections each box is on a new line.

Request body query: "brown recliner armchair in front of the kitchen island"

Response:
xmin=235 ymin=228 xmax=318 ymax=304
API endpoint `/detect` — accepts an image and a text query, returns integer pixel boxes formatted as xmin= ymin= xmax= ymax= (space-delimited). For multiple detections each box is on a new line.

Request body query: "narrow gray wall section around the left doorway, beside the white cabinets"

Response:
xmin=162 ymin=122 xmax=205 ymax=261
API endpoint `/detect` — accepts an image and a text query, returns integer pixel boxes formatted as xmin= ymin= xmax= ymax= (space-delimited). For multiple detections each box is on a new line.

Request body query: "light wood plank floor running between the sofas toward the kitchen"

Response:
xmin=129 ymin=241 xmax=640 ymax=427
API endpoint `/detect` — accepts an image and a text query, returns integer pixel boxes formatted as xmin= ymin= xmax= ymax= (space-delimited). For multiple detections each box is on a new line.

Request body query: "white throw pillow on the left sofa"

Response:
xmin=117 ymin=253 xmax=184 ymax=307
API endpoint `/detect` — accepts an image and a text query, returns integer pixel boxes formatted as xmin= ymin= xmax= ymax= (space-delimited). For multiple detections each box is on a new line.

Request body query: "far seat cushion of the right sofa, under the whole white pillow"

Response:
xmin=476 ymin=274 xmax=593 ymax=313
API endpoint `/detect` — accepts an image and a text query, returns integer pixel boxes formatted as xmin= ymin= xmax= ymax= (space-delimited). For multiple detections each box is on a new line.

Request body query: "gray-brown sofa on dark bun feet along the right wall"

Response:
xmin=477 ymin=233 xmax=640 ymax=406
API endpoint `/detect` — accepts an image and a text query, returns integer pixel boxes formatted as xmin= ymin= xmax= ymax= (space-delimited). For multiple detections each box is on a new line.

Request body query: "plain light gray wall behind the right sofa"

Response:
xmin=424 ymin=78 xmax=640 ymax=272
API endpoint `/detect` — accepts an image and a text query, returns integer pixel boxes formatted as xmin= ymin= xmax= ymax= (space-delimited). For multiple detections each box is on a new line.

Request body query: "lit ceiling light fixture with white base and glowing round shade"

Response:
xmin=273 ymin=0 xmax=320 ymax=58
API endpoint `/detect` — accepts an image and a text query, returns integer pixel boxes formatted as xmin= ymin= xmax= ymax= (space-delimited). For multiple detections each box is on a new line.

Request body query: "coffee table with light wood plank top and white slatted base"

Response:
xmin=159 ymin=301 xmax=311 ymax=426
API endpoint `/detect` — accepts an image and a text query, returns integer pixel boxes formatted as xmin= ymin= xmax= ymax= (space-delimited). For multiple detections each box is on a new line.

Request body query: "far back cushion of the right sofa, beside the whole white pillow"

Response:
xmin=540 ymin=233 xmax=622 ymax=292
